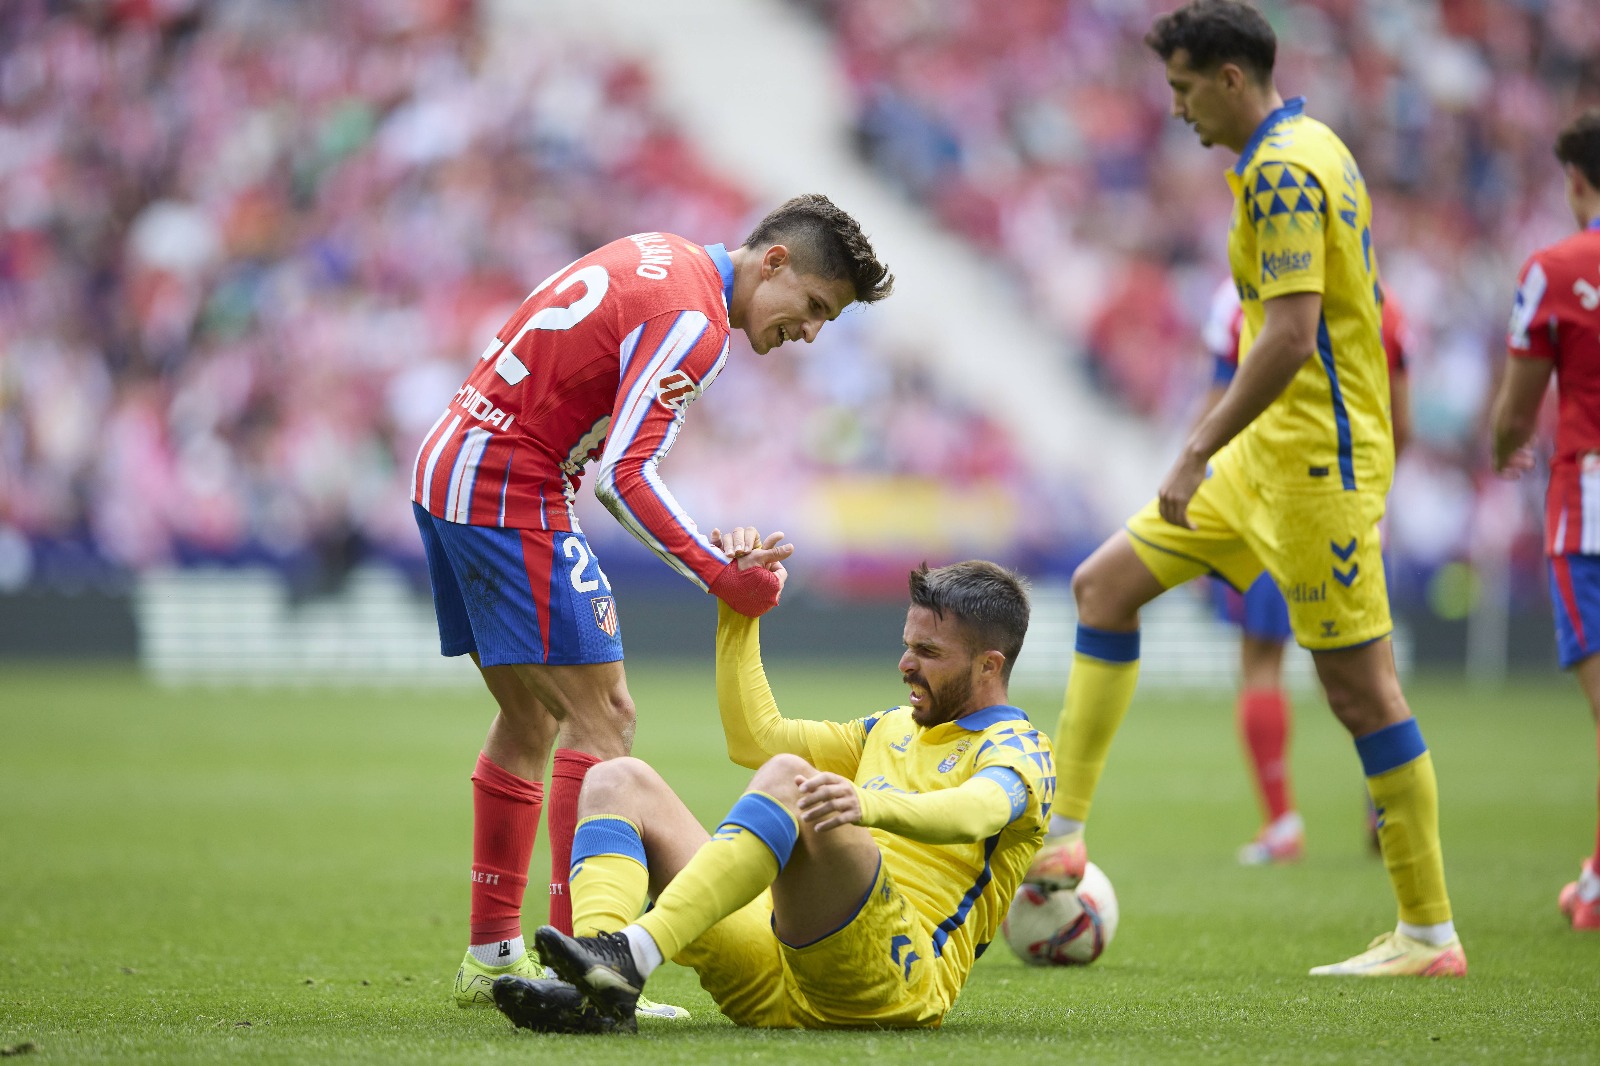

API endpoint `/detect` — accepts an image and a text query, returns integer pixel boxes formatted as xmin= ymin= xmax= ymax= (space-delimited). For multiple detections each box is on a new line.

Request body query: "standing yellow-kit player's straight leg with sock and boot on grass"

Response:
xmin=1312 ymin=640 xmax=1467 ymax=976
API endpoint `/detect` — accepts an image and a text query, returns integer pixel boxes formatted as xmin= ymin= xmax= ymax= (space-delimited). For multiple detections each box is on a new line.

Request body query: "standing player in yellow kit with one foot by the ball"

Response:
xmin=1027 ymin=0 xmax=1467 ymax=976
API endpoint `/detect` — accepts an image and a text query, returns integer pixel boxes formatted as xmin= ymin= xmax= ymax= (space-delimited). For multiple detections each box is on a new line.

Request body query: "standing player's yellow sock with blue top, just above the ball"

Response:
xmin=1054 ymin=624 xmax=1139 ymax=821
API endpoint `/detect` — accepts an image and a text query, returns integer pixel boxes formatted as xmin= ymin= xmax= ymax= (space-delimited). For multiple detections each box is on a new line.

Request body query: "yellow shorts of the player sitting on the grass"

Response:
xmin=674 ymin=861 xmax=950 ymax=1029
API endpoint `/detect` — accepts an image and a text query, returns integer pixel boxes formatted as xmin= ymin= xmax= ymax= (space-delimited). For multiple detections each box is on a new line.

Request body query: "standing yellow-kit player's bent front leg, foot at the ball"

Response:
xmin=1027 ymin=531 xmax=1166 ymax=888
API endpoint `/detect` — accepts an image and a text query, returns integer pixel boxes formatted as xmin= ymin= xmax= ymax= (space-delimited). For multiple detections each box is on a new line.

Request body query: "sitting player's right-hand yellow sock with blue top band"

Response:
xmin=637 ymin=792 xmax=798 ymax=959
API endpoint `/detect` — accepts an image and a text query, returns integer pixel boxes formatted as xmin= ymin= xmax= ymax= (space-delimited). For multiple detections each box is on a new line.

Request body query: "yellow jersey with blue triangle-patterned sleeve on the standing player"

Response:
xmin=1219 ymin=96 xmax=1395 ymax=493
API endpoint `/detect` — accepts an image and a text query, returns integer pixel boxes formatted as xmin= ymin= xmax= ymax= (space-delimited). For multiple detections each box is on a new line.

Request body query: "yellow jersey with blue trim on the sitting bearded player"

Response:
xmin=838 ymin=704 xmax=1056 ymax=1002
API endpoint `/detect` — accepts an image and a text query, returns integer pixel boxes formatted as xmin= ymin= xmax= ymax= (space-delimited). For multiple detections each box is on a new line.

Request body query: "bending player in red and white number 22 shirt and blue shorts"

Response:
xmin=411 ymin=188 xmax=894 ymax=1010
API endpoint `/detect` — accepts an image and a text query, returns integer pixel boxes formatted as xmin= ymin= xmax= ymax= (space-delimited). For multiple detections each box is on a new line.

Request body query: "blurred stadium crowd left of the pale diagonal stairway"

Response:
xmin=0 ymin=0 xmax=1016 ymax=591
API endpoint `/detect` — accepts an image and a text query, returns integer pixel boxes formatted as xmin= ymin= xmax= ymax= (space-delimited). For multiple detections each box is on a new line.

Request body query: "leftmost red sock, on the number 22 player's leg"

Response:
xmin=469 ymin=752 xmax=547 ymax=944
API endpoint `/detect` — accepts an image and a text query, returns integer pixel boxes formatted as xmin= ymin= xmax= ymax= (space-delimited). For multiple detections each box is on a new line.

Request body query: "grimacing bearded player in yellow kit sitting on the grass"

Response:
xmin=493 ymin=528 xmax=1054 ymax=1032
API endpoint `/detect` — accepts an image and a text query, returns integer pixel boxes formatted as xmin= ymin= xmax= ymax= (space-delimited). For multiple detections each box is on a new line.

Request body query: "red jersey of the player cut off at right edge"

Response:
xmin=1506 ymin=219 xmax=1600 ymax=555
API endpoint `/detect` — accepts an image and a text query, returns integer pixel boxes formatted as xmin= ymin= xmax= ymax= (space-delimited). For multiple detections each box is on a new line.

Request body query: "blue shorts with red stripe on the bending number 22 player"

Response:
xmin=411 ymin=503 xmax=622 ymax=666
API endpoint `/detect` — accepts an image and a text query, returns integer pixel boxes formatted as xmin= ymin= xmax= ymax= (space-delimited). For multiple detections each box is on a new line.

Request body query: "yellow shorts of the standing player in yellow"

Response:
xmin=1126 ymin=455 xmax=1394 ymax=651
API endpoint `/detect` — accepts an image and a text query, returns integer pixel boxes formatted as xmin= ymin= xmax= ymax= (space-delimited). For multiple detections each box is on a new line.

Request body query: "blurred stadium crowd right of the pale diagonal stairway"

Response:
xmin=806 ymin=0 xmax=1600 ymax=597
